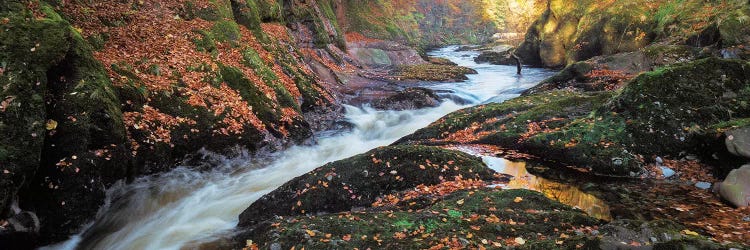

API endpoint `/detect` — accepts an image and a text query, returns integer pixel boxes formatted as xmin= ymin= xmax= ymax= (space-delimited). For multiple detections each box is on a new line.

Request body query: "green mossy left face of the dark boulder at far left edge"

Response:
xmin=0 ymin=9 xmax=71 ymax=217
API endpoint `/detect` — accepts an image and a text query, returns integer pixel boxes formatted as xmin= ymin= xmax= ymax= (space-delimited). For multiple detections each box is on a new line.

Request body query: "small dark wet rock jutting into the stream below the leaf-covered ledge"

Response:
xmin=372 ymin=88 xmax=440 ymax=110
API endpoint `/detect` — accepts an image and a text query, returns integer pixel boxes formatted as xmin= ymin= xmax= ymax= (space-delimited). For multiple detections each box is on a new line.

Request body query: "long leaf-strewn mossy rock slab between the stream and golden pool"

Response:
xmin=396 ymin=91 xmax=641 ymax=176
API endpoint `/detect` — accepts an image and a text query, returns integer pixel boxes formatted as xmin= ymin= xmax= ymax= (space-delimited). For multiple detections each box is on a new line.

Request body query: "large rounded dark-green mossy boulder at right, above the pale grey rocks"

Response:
xmin=606 ymin=58 xmax=750 ymax=155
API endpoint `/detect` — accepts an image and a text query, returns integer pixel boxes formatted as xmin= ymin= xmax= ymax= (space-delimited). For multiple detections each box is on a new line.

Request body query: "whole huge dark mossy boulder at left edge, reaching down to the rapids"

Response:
xmin=0 ymin=4 xmax=130 ymax=243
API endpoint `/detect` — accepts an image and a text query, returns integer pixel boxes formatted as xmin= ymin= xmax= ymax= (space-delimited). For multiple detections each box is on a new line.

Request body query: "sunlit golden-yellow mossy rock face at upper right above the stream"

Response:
xmin=516 ymin=0 xmax=750 ymax=68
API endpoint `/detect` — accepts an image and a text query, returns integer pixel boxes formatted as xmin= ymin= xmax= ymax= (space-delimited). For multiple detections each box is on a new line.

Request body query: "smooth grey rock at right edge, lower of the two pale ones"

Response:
xmin=719 ymin=165 xmax=750 ymax=207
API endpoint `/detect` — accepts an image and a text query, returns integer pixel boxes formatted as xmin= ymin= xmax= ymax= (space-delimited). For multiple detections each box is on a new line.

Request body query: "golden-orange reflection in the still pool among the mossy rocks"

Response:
xmin=482 ymin=156 xmax=612 ymax=221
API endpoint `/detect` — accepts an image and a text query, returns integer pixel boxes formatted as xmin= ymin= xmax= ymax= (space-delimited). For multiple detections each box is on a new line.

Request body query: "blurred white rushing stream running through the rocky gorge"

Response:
xmin=44 ymin=47 xmax=553 ymax=249
